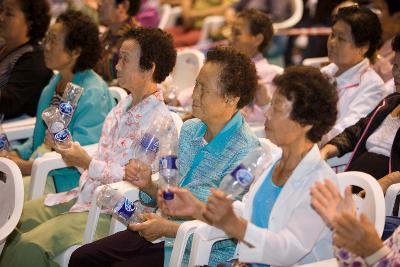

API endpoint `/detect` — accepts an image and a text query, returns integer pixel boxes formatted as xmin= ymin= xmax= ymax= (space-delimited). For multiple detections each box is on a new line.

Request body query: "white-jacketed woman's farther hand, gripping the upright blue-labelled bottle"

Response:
xmin=157 ymin=187 xmax=205 ymax=219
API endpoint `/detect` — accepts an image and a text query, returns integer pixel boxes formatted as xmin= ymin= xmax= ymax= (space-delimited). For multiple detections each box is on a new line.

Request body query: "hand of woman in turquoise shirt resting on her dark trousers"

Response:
xmin=128 ymin=213 xmax=179 ymax=241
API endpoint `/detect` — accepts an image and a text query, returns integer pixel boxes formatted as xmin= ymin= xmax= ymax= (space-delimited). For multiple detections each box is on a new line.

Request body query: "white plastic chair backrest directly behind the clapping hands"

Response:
xmin=338 ymin=171 xmax=385 ymax=236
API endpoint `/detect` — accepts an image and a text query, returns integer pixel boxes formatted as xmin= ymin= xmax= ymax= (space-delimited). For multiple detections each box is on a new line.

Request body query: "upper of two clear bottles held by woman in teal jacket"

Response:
xmin=58 ymin=82 xmax=83 ymax=126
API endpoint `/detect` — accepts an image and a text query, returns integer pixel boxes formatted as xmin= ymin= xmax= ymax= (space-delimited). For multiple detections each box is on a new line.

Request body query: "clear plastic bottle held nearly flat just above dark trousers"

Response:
xmin=97 ymin=185 xmax=154 ymax=225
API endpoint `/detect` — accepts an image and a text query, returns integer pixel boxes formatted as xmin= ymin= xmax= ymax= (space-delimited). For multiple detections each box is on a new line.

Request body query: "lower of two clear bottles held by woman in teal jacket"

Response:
xmin=42 ymin=107 xmax=72 ymax=148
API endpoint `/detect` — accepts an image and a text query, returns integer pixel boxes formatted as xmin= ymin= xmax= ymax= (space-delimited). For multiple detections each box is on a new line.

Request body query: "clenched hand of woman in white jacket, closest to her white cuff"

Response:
xmin=203 ymin=188 xmax=247 ymax=241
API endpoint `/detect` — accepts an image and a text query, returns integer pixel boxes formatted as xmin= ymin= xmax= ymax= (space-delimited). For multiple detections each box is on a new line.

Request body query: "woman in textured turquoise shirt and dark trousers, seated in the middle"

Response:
xmin=69 ymin=48 xmax=259 ymax=266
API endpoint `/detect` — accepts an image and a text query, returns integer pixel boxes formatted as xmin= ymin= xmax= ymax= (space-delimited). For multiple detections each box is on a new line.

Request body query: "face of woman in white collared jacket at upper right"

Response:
xmin=328 ymin=20 xmax=368 ymax=69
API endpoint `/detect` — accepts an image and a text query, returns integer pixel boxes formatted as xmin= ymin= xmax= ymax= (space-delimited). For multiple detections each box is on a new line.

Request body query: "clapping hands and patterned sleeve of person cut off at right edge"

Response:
xmin=311 ymin=181 xmax=400 ymax=267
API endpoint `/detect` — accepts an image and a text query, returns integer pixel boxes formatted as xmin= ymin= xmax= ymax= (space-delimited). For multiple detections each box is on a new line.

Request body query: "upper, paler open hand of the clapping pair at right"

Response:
xmin=310 ymin=180 xmax=355 ymax=228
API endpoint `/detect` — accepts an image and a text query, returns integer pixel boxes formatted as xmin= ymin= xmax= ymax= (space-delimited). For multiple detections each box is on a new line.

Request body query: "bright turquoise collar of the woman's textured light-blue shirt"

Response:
xmin=193 ymin=111 xmax=244 ymax=153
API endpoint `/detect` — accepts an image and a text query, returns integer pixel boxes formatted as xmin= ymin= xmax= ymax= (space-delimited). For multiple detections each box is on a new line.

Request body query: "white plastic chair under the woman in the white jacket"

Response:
xmin=175 ymin=172 xmax=385 ymax=266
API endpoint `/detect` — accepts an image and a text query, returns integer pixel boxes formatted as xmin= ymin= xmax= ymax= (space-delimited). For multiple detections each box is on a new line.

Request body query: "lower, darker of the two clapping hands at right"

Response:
xmin=333 ymin=212 xmax=383 ymax=258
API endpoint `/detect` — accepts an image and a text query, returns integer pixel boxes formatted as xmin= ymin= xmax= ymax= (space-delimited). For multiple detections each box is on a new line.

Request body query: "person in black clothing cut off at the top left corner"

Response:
xmin=0 ymin=0 xmax=52 ymax=119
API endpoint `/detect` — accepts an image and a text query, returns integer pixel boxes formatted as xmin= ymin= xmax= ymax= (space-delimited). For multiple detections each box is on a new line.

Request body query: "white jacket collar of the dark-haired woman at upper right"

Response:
xmin=322 ymin=58 xmax=370 ymax=89
